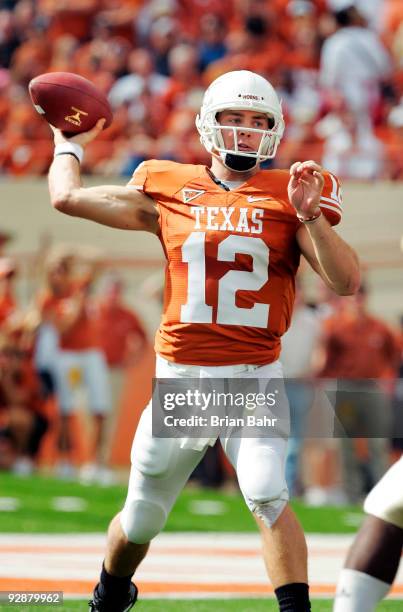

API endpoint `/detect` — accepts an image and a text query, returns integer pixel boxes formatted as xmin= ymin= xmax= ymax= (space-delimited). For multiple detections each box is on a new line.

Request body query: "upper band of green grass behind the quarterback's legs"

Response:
xmin=0 ymin=474 xmax=363 ymax=533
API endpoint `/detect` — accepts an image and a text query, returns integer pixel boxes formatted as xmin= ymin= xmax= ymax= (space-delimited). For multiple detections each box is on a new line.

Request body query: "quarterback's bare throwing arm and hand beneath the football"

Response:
xmin=49 ymin=119 xmax=159 ymax=234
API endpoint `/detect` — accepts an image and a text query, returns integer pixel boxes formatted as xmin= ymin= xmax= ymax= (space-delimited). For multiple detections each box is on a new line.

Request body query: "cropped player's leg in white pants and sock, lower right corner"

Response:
xmin=333 ymin=457 xmax=403 ymax=612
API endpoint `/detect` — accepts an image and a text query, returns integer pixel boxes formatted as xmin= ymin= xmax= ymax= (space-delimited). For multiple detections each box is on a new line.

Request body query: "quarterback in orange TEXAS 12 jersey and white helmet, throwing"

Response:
xmin=49 ymin=71 xmax=360 ymax=612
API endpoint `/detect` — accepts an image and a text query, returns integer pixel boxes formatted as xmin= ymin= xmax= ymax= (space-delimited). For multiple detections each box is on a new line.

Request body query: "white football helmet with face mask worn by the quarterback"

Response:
xmin=196 ymin=70 xmax=285 ymax=171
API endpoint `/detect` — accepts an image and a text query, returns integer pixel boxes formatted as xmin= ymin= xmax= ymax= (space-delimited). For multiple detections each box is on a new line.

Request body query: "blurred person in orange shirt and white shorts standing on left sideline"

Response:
xmin=36 ymin=255 xmax=111 ymax=478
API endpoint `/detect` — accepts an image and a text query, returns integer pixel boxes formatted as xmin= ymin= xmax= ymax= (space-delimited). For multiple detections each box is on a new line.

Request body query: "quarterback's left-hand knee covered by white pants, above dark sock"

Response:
xmin=120 ymin=499 xmax=167 ymax=544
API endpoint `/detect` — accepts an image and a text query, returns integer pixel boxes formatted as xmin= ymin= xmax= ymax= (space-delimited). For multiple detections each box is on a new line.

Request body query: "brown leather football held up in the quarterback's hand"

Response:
xmin=29 ymin=72 xmax=112 ymax=135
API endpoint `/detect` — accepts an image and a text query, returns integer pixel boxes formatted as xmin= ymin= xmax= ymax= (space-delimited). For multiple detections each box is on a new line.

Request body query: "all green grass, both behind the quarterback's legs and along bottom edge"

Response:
xmin=0 ymin=474 xmax=402 ymax=612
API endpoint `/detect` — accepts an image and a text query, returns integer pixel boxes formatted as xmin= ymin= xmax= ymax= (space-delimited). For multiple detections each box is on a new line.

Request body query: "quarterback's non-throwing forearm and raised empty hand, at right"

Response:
xmin=288 ymin=161 xmax=360 ymax=295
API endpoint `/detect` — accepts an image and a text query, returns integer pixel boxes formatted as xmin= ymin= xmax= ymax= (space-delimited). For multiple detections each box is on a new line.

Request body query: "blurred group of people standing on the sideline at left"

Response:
xmin=0 ymin=234 xmax=147 ymax=484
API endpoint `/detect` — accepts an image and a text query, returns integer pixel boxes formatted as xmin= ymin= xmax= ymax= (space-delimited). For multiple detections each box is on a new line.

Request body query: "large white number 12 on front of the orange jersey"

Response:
xmin=180 ymin=232 xmax=270 ymax=328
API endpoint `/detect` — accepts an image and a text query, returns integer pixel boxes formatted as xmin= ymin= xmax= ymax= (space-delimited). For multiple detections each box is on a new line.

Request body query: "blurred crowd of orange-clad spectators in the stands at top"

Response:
xmin=0 ymin=0 xmax=403 ymax=180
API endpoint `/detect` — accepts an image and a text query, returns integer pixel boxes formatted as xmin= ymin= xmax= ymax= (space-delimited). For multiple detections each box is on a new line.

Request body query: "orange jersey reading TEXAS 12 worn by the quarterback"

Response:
xmin=129 ymin=160 xmax=341 ymax=366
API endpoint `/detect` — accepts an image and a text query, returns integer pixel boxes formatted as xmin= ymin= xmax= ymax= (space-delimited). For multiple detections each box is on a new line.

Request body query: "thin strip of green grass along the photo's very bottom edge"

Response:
xmin=0 ymin=599 xmax=402 ymax=612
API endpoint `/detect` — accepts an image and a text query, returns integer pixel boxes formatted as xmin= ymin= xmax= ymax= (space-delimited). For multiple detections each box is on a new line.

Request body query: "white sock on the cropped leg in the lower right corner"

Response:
xmin=333 ymin=569 xmax=391 ymax=612
